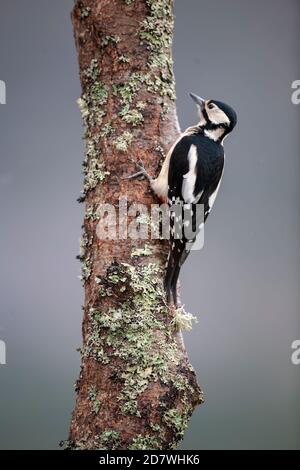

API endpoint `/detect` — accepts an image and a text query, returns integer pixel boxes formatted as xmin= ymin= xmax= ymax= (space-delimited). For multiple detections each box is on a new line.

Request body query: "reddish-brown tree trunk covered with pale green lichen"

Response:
xmin=67 ymin=0 xmax=202 ymax=450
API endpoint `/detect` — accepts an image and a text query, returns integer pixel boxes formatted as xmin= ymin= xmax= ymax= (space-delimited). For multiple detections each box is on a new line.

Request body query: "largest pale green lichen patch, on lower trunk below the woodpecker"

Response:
xmin=84 ymin=263 xmax=199 ymax=426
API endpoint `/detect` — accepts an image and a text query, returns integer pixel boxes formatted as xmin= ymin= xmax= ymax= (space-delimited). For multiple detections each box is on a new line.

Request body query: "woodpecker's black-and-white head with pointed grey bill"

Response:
xmin=190 ymin=93 xmax=237 ymax=142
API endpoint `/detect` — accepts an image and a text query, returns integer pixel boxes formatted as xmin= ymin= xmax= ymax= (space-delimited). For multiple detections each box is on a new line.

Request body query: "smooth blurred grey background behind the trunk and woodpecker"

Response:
xmin=0 ymin=0 xmax=300 ymax=449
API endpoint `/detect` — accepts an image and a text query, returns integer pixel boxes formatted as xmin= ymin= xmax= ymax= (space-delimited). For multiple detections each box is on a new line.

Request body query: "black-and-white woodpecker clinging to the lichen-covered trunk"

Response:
xmin=129 ymin=93 xmax=237 ymax=306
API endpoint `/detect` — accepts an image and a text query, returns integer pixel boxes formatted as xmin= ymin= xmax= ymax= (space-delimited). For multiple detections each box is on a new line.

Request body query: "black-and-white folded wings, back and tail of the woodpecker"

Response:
xmin=165 ymin=137 xmax=224 ymax=303
